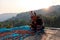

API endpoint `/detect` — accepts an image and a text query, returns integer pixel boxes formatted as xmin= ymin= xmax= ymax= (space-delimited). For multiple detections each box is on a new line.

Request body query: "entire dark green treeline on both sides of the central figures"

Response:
xmin=0 ymin=14 xmax=60 ymax=28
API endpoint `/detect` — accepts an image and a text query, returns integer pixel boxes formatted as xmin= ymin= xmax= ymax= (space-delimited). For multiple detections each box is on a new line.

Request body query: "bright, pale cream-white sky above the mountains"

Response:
xmin=0 ymin=0 xmax=60 ymax=14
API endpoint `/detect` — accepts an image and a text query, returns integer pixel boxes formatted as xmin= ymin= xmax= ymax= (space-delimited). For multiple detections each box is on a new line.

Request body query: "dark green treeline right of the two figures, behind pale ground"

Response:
xmin=43 ymin=16 xmax=60 ymax=28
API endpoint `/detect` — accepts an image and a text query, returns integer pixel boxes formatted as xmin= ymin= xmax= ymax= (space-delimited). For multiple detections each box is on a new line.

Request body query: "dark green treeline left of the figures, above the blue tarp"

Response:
xmin=0 ymin=19 xmax=28 ymax=28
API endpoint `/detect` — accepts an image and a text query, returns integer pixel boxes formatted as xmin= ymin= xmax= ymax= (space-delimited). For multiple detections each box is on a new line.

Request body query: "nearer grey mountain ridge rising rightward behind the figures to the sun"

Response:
xmin=5 ymin=5 xmax=60 ymax=21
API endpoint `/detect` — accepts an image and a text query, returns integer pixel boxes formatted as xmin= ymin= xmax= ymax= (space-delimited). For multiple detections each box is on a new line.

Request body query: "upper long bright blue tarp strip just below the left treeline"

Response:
xmin=0 ymin=25 xmax=31 ymax=33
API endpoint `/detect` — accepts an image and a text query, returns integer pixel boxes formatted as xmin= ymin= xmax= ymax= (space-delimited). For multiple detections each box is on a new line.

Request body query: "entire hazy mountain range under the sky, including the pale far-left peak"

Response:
xmin=0 ymin=5 xmax=60 ymax=21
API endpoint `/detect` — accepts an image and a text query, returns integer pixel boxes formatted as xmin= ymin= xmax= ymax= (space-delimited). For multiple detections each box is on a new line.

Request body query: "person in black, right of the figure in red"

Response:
xmin=36 ymin=16 xmax=45 ymax=33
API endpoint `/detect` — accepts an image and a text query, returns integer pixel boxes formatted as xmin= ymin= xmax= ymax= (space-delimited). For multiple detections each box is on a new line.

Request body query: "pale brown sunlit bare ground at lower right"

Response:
xmin=24 ymin=29 xmax=60 ymax=40
